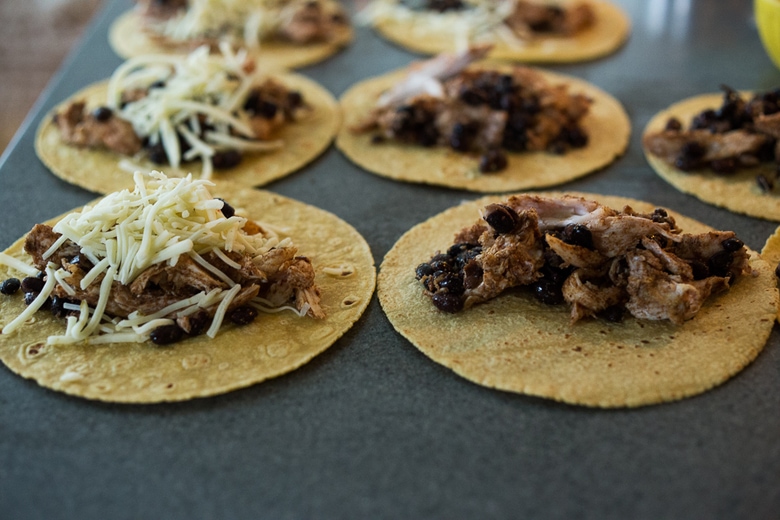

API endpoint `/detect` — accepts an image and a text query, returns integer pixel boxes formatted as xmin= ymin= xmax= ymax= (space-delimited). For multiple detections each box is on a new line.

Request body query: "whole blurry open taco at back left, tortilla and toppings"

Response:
xmin=109 ymin=0 xmax=352 ymax=68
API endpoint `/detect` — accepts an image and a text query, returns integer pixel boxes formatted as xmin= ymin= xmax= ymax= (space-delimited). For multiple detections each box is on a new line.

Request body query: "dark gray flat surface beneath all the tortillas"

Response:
xmin=0 ymin=0 xmax=780 ymax=520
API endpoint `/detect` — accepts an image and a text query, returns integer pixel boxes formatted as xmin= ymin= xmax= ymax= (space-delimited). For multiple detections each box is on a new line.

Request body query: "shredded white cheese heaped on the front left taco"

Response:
xmin=0 ymin=172 xmax=308 ymax=344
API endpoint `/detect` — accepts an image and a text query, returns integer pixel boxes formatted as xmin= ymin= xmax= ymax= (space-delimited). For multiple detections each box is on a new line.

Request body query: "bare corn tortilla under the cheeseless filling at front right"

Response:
xmin=378 ymin=193 xmax=778 ymax=408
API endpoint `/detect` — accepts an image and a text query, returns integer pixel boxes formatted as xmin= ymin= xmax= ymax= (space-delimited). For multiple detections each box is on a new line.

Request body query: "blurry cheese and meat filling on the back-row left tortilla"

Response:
xmin=137 ymin=0 xmax=348 ymax=49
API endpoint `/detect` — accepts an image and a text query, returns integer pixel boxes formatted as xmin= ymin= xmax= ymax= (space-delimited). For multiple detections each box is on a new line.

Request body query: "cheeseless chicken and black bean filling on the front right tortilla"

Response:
xmin=416 ymin=195 xmax=751 ymax=325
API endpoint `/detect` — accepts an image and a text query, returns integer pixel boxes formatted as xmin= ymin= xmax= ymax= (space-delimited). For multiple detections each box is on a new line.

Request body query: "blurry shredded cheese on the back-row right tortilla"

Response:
xmin=357 ymin=0 xmax=525 ymax=49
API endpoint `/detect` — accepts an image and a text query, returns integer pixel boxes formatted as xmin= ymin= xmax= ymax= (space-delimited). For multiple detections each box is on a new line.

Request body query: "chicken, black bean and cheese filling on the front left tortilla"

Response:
xmin=0 ymin=172 xmax=324 ymax=344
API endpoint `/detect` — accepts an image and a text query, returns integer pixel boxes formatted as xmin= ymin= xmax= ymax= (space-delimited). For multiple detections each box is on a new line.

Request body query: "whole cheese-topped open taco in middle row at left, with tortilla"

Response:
xmin=36 ymin=46 xmax=340 ymax=193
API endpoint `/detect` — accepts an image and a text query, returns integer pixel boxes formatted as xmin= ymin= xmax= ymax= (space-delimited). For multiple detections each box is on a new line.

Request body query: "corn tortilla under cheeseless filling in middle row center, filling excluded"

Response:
xmin=336 ymin=64 xmax=631 ymax=192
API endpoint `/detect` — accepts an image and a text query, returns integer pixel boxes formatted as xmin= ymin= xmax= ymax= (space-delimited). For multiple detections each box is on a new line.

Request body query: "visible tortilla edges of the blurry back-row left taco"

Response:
xmin=108 ymin=10 xmax=353 ymax=70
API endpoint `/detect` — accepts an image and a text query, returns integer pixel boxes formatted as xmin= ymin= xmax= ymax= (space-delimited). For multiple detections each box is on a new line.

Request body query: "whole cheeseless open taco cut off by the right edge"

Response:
xmin=642 ymin=86 xmax=780 ymax=220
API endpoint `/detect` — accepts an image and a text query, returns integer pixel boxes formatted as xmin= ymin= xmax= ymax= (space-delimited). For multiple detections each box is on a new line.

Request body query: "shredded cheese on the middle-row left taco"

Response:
xmin=106 ymin=44 xmax=283 ymax=179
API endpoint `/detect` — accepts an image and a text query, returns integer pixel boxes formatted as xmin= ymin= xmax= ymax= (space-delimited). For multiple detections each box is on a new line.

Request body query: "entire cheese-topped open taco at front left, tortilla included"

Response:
xmin=0 ymin=172 xmax=374 ymax=402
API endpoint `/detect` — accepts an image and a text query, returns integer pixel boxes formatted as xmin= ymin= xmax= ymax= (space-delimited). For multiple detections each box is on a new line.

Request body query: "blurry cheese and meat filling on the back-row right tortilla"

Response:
xmin=364 ymin=0 xmax=595 ymax=46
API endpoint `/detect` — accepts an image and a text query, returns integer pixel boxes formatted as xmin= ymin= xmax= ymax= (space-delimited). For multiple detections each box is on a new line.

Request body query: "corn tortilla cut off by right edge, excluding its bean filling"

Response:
xmin=643 ymin=93 xmax=780 ymax=221
